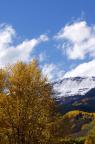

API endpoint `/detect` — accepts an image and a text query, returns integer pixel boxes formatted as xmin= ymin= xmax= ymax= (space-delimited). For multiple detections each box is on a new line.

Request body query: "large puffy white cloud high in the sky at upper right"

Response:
xmin=56 ymin=21 xmax=95 ymax=59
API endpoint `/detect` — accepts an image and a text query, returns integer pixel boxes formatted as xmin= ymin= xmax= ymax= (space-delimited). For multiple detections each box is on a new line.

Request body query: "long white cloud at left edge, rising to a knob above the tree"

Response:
xmin=0 ymin=25 xmax=49 ymax=66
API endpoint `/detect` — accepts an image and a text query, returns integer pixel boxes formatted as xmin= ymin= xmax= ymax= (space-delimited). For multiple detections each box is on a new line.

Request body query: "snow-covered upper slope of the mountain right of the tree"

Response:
xmin=54 ymin=77 xmax=95 ymax=98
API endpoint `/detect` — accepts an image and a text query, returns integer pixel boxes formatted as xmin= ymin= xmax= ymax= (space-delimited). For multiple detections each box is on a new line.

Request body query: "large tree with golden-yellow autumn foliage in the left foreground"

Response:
xmin=0 ymin=60 xmax=54 ymax=144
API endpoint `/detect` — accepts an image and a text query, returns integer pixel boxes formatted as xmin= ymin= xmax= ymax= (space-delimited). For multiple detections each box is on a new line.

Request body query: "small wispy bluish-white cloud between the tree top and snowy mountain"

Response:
xmin=42 ymin=63 xmax=64 ymax=82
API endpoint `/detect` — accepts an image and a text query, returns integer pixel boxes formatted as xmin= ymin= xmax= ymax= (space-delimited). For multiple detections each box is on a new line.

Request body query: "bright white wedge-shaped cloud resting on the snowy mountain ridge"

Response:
xmin=64 ymin=60 xmax=95 ymax=78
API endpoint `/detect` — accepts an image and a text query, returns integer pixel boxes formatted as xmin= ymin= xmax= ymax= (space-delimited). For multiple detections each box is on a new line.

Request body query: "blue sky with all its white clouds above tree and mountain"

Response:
xmin=0 ymin=0 xmax=95 ymax=81
